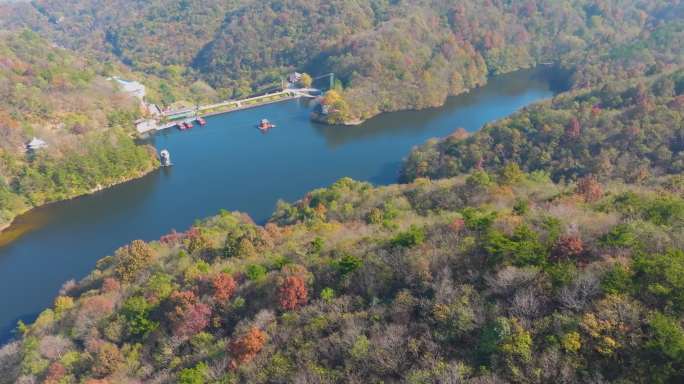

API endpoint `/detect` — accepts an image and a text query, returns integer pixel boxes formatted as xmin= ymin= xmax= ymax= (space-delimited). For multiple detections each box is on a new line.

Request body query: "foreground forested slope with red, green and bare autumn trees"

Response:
xmin=0 ymin=172 xmax=684 ymax=384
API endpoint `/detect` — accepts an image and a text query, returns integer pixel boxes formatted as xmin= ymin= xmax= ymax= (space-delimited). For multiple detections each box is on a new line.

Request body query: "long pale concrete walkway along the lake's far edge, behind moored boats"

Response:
xmin=136 ymin=88 xmax=321 ymax=133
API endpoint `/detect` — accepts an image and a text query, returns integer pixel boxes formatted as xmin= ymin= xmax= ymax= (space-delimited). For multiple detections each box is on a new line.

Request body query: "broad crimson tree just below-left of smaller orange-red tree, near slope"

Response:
xmin=168 ymin=291 xmax=211 ymax=338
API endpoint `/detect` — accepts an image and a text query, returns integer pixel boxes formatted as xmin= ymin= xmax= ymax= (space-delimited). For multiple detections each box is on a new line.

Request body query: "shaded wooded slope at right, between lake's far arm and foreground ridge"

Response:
xmin=402 ymin=70 xmax=684 ymax=183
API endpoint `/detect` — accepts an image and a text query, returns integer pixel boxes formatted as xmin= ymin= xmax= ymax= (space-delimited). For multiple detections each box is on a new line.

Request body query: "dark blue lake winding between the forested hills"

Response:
xmin=0 ymin=68 xmax=561 ymax=343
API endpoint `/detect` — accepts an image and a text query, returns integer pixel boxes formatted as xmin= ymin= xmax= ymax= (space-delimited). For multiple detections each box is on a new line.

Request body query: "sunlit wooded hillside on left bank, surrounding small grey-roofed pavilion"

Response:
xmin=0 ymin=31 xmax=156 ymax=228
